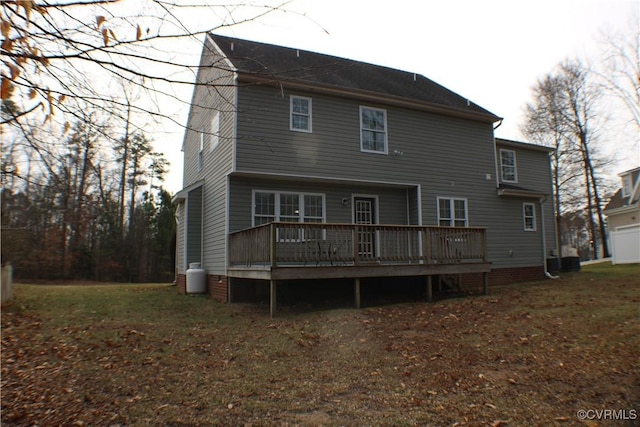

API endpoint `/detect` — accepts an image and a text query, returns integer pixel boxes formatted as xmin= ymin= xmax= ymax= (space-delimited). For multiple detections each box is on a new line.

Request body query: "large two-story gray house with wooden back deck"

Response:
xmin=175 ymin=34 xmax=556 ymax=309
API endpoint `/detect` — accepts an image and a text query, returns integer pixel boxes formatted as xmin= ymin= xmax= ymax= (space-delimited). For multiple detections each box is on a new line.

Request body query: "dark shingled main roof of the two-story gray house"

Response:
xmin=209 ymin=34 xmax=500 ymax=122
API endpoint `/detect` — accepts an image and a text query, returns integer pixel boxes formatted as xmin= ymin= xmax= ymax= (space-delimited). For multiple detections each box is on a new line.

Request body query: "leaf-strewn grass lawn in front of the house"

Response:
xmin=1 ymin=264 xmax=640 ymax=427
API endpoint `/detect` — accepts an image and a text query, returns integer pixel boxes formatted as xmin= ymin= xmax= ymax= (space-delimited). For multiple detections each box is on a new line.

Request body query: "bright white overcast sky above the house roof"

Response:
xmin=159 ymin=0 xmax=640 ymax=192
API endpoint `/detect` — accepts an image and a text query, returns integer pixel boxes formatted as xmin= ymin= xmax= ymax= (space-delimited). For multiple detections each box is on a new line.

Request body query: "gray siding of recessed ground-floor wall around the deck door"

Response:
xmin=229 ymin=177 xmax=407 ymax=232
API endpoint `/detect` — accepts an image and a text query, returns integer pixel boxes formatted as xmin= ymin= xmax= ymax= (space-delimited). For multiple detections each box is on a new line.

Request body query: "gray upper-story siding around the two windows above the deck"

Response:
xmin=237 ymin=87 xmax=494 ymax=185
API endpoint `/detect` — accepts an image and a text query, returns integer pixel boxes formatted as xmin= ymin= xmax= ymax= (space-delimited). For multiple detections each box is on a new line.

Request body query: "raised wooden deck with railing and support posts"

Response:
xmin=227 ymin=222 xmax=491 ymax=314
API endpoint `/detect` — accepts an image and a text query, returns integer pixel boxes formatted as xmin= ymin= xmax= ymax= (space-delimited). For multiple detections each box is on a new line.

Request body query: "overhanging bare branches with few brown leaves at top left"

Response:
xmin=0 ymin=0 xmax=286 ymax=127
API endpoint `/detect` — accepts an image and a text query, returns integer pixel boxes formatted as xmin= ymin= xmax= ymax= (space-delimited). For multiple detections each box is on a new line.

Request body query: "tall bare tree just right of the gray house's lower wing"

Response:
xmin=522 ymin=61 xmax=609 ymax=257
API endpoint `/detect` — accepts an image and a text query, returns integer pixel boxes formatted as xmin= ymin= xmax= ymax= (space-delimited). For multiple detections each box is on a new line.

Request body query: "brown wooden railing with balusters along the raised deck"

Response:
xmin=229 ymin=222 xmax=487 ymax=267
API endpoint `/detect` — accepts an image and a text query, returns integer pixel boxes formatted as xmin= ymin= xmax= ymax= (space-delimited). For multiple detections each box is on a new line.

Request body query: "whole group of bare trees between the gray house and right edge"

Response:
xmin=522 ymin=21 xmax=640 ymax=260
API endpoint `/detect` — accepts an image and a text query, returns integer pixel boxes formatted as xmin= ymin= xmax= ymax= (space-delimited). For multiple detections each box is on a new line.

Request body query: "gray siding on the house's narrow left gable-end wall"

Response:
xmin=179 ymin=35 xmax=236 ymax=275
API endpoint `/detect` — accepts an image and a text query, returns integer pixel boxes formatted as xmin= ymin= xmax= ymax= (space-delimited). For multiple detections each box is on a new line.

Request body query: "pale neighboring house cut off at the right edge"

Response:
xmin=604 ymin=168 xmax=640 ymax=264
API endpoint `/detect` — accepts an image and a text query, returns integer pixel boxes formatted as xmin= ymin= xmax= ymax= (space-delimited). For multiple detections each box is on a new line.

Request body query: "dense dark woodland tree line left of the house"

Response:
xmin=1 ymin=102 xmax=176 ymax=282
